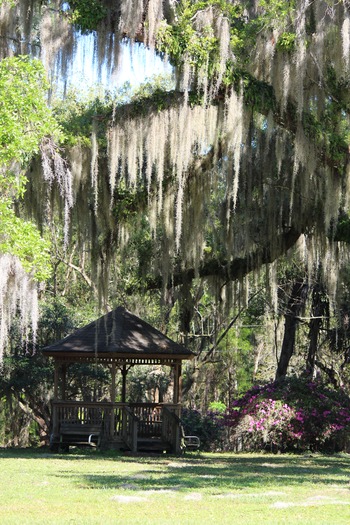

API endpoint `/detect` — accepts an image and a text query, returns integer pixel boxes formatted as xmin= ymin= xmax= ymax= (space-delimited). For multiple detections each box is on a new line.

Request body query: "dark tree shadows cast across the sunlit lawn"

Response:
xmin=0 ymin=449 xmax=350 ymax=494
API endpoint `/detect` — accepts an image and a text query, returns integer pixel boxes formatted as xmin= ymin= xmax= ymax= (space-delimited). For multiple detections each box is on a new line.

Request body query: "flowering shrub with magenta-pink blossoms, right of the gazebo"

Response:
xmin=224 ymin=378 xmax=350 ymax=451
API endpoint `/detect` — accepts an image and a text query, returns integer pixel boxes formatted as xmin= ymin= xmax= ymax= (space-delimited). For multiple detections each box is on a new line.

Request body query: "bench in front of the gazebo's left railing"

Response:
xmin=59 ymin=423 xmax=102 ymax=447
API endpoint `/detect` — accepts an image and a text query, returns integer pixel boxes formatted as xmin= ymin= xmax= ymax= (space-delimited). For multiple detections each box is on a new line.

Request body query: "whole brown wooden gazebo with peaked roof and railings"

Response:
xmin=43 ymin=307 xmax=194 ymax=453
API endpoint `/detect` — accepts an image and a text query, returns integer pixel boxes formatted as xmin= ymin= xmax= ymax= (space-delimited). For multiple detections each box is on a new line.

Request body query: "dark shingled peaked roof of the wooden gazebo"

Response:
xmin=43 ymin=306 xmax=194 ymax=360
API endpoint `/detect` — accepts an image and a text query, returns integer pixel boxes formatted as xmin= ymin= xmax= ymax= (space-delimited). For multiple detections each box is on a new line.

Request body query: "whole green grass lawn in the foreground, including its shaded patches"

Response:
xmin=0 ymin=449 xmax=350 ymax=525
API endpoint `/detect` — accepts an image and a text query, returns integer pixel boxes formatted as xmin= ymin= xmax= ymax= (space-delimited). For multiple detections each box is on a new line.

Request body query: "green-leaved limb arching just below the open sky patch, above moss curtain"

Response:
xmin=55 ymin=64 xmax=348 ymax=169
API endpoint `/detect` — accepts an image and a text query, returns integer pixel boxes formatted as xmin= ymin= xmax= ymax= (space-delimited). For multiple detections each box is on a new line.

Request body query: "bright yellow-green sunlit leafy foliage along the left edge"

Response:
xmin=0 ymin=56 xmax=59 ymax=280
